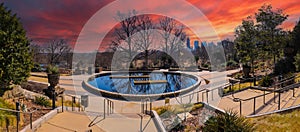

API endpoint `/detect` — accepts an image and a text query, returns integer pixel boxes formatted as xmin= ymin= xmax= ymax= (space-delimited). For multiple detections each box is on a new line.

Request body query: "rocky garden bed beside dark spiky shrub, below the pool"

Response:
xmin=154 ymin=103 xmax=215 ymax=132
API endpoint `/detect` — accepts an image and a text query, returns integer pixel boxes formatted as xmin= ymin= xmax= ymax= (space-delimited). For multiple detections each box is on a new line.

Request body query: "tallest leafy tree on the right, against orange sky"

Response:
xmin=255 ymin=4 xmax=288 ymax=67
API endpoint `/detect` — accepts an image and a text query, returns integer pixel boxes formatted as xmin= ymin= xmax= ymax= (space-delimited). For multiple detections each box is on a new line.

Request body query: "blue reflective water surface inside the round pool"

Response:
xmin=88 ymin=72 xmax=197 ymax=95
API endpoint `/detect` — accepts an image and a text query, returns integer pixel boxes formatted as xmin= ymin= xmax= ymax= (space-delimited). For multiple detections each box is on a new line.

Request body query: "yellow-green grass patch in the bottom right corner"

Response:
xmin=250 ymin=110 xmax=300 ymax=132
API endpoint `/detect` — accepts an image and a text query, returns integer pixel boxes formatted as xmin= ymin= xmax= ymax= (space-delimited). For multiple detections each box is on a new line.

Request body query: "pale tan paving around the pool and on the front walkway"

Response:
xmin=37 ymin=70 xmax=237 ymax=132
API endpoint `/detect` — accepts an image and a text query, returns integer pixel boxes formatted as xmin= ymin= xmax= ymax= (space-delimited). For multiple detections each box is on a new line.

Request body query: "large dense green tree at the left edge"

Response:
xmin=0 ymin=3 xmax=33 ymax=87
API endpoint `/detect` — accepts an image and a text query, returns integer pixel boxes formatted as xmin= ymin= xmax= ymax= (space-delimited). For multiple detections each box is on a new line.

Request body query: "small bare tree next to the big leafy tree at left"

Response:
xmin=44 ymin=39 xmax=72 ymax=64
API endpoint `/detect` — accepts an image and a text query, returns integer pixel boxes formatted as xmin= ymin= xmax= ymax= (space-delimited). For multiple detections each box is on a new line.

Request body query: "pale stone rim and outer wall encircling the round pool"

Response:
xmin=82 ymin=71 xmax=201 ymax=101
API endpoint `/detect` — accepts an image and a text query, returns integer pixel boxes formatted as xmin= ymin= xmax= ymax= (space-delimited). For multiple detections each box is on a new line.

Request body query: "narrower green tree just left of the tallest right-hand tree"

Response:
xmin=234 ymin=16 xmax=259 ymax=76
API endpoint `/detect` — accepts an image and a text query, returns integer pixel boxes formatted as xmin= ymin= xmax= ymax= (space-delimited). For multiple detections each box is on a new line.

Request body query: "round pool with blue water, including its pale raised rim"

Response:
xmin=83 ymin=71 xmax=200 ymax=101
